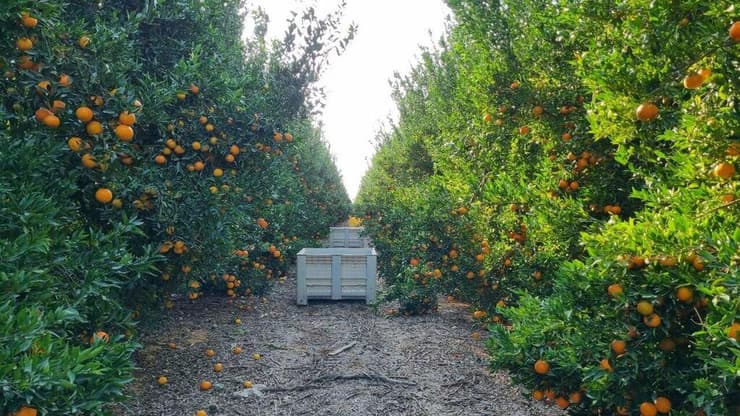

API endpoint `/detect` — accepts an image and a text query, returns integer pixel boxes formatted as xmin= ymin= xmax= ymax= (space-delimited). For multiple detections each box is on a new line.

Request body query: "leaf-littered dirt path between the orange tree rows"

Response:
xmin=117 ymin=279 xmax=561 ymax=416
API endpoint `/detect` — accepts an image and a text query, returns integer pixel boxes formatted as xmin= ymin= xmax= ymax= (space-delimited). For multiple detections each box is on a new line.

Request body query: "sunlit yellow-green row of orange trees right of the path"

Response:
xmin=355 ymin=0 xmax=740 ymax=416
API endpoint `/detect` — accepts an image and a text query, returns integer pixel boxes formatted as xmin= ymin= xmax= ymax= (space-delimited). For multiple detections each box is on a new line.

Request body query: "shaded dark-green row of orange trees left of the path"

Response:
xmin=0 ymin=0 xmax=353 ymax=416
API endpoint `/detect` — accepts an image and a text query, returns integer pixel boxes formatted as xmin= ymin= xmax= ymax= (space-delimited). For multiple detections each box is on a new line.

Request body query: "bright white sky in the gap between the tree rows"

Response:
xmin=249 ymin=0 xmax=449 ymax=200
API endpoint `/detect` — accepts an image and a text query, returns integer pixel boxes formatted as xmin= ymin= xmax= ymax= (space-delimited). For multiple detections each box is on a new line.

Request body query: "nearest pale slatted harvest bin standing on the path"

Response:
xmin=298 ymin=247 xmax=377 ymax=305
